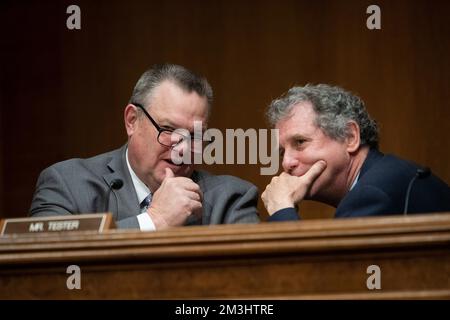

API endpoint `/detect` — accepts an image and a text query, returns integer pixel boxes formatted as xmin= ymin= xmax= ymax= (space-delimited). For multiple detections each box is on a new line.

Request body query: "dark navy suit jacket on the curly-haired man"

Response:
xmin=269 ymin=149 xmax=450 ymax=221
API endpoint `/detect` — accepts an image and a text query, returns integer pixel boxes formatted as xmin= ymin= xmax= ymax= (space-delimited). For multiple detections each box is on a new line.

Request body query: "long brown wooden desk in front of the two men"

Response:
xmin=0 ymin=214 xmax=450 ymax=299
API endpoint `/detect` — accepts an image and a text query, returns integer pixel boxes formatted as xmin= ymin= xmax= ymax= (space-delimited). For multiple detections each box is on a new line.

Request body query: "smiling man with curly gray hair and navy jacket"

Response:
xmin=261 ymin=84 xmax=450 ymax=221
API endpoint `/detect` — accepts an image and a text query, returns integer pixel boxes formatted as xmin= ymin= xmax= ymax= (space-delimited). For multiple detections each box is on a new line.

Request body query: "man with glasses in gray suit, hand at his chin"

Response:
xmin=30 ymin=64 xmax=259 ymax=230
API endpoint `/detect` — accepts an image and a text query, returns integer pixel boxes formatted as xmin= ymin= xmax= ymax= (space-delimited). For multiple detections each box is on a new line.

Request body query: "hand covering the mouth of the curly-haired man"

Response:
xmin=261 ymin=160 xmax=326 ymax=215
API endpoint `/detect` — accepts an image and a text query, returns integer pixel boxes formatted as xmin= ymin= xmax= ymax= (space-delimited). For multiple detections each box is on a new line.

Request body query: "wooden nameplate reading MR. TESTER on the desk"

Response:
xmin=0 ymin=213 xmax=114 ymax=236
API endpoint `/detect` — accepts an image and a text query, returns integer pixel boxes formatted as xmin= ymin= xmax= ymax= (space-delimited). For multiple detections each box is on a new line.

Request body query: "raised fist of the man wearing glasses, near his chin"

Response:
xmin=147 ymin=168 xmax=203 ymax=230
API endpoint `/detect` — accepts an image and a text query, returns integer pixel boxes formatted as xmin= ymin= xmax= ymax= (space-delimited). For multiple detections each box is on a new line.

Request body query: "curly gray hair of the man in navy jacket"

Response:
xmin=266 ymin=84 xmax=378 ymax=149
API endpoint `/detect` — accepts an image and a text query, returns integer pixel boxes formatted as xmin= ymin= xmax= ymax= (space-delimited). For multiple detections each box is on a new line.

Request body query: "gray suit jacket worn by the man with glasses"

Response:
xmin=30 ymin=145 xmax=259 ymax=228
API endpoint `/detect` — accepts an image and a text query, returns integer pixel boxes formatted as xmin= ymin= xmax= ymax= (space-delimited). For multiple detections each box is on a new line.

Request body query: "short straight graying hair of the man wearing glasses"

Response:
xmin=129 ymin=63 xmax=213 ymax=108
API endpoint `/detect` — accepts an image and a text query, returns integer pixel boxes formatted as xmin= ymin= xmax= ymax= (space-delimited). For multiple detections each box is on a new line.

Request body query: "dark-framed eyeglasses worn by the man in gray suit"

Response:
xmin=132 ymin=103 xmax=212 ymax=153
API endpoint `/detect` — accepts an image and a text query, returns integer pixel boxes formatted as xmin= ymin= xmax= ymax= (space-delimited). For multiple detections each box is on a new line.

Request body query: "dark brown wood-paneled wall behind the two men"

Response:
xmin=0 ymin=0 xmax=450 ymax=217
